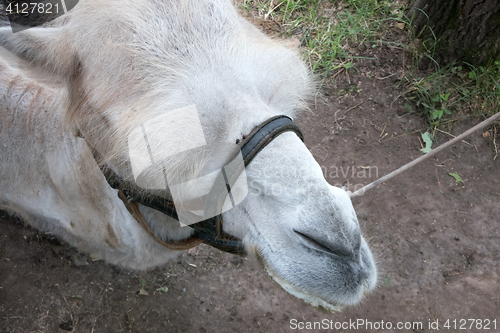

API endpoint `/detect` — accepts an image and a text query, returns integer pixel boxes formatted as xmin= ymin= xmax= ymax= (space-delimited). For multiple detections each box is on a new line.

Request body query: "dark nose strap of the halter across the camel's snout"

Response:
xmin=190 ymin=116 xmax=304 ymax=254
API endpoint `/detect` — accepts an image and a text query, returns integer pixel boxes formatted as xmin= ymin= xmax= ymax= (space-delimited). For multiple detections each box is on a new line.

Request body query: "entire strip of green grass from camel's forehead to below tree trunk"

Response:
xmin=242 ymin=0 xmax=500 ymax=133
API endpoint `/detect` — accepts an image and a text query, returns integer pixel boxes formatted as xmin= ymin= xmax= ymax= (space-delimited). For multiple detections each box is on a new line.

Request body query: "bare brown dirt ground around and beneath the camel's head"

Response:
xmin=0 ymin=8 xmax=500 ymax=333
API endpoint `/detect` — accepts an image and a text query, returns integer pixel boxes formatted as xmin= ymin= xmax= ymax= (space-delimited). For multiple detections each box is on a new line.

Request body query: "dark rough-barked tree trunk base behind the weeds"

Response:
xmin=409 ymin=0 xmax=500 ymax=66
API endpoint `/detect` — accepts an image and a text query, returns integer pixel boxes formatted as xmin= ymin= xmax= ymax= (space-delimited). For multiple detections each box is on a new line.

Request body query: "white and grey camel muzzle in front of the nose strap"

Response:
xmin=226 ymin=134 xmax=377 ymax=311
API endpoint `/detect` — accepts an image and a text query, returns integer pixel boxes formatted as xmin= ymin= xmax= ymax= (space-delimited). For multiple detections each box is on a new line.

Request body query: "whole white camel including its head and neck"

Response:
xmin=0 ymin=0 xmax=377 ymax=311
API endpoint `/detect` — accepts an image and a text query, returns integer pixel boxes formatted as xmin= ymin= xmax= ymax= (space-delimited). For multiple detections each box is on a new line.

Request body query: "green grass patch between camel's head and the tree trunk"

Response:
xmin=243 ymin=0 xmax=402 ymax=78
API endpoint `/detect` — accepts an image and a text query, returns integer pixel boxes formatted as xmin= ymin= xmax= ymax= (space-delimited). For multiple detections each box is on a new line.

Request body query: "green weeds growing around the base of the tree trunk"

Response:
xmin=403 ymin=7 xmax=500 ymax=131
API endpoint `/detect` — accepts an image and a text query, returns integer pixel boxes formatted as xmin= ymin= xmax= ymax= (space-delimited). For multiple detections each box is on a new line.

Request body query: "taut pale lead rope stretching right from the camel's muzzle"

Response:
xmin=349 ymin=112 xmax=500 ymax=198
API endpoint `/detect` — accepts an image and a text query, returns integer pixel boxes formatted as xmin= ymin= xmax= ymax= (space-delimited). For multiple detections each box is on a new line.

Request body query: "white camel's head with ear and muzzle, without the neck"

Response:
xmin=0 ymin=0 xmax=377 ymax=311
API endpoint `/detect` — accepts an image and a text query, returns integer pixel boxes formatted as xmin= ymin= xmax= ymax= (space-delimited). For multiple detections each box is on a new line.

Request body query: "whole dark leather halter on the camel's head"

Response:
xmin=89 ymin=116 xmax=304 ymax=254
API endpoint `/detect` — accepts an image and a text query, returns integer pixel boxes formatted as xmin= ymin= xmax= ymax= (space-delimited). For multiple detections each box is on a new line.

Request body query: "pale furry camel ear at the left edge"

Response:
xmin=0 ymin=27 xmax=75 ymax=75
